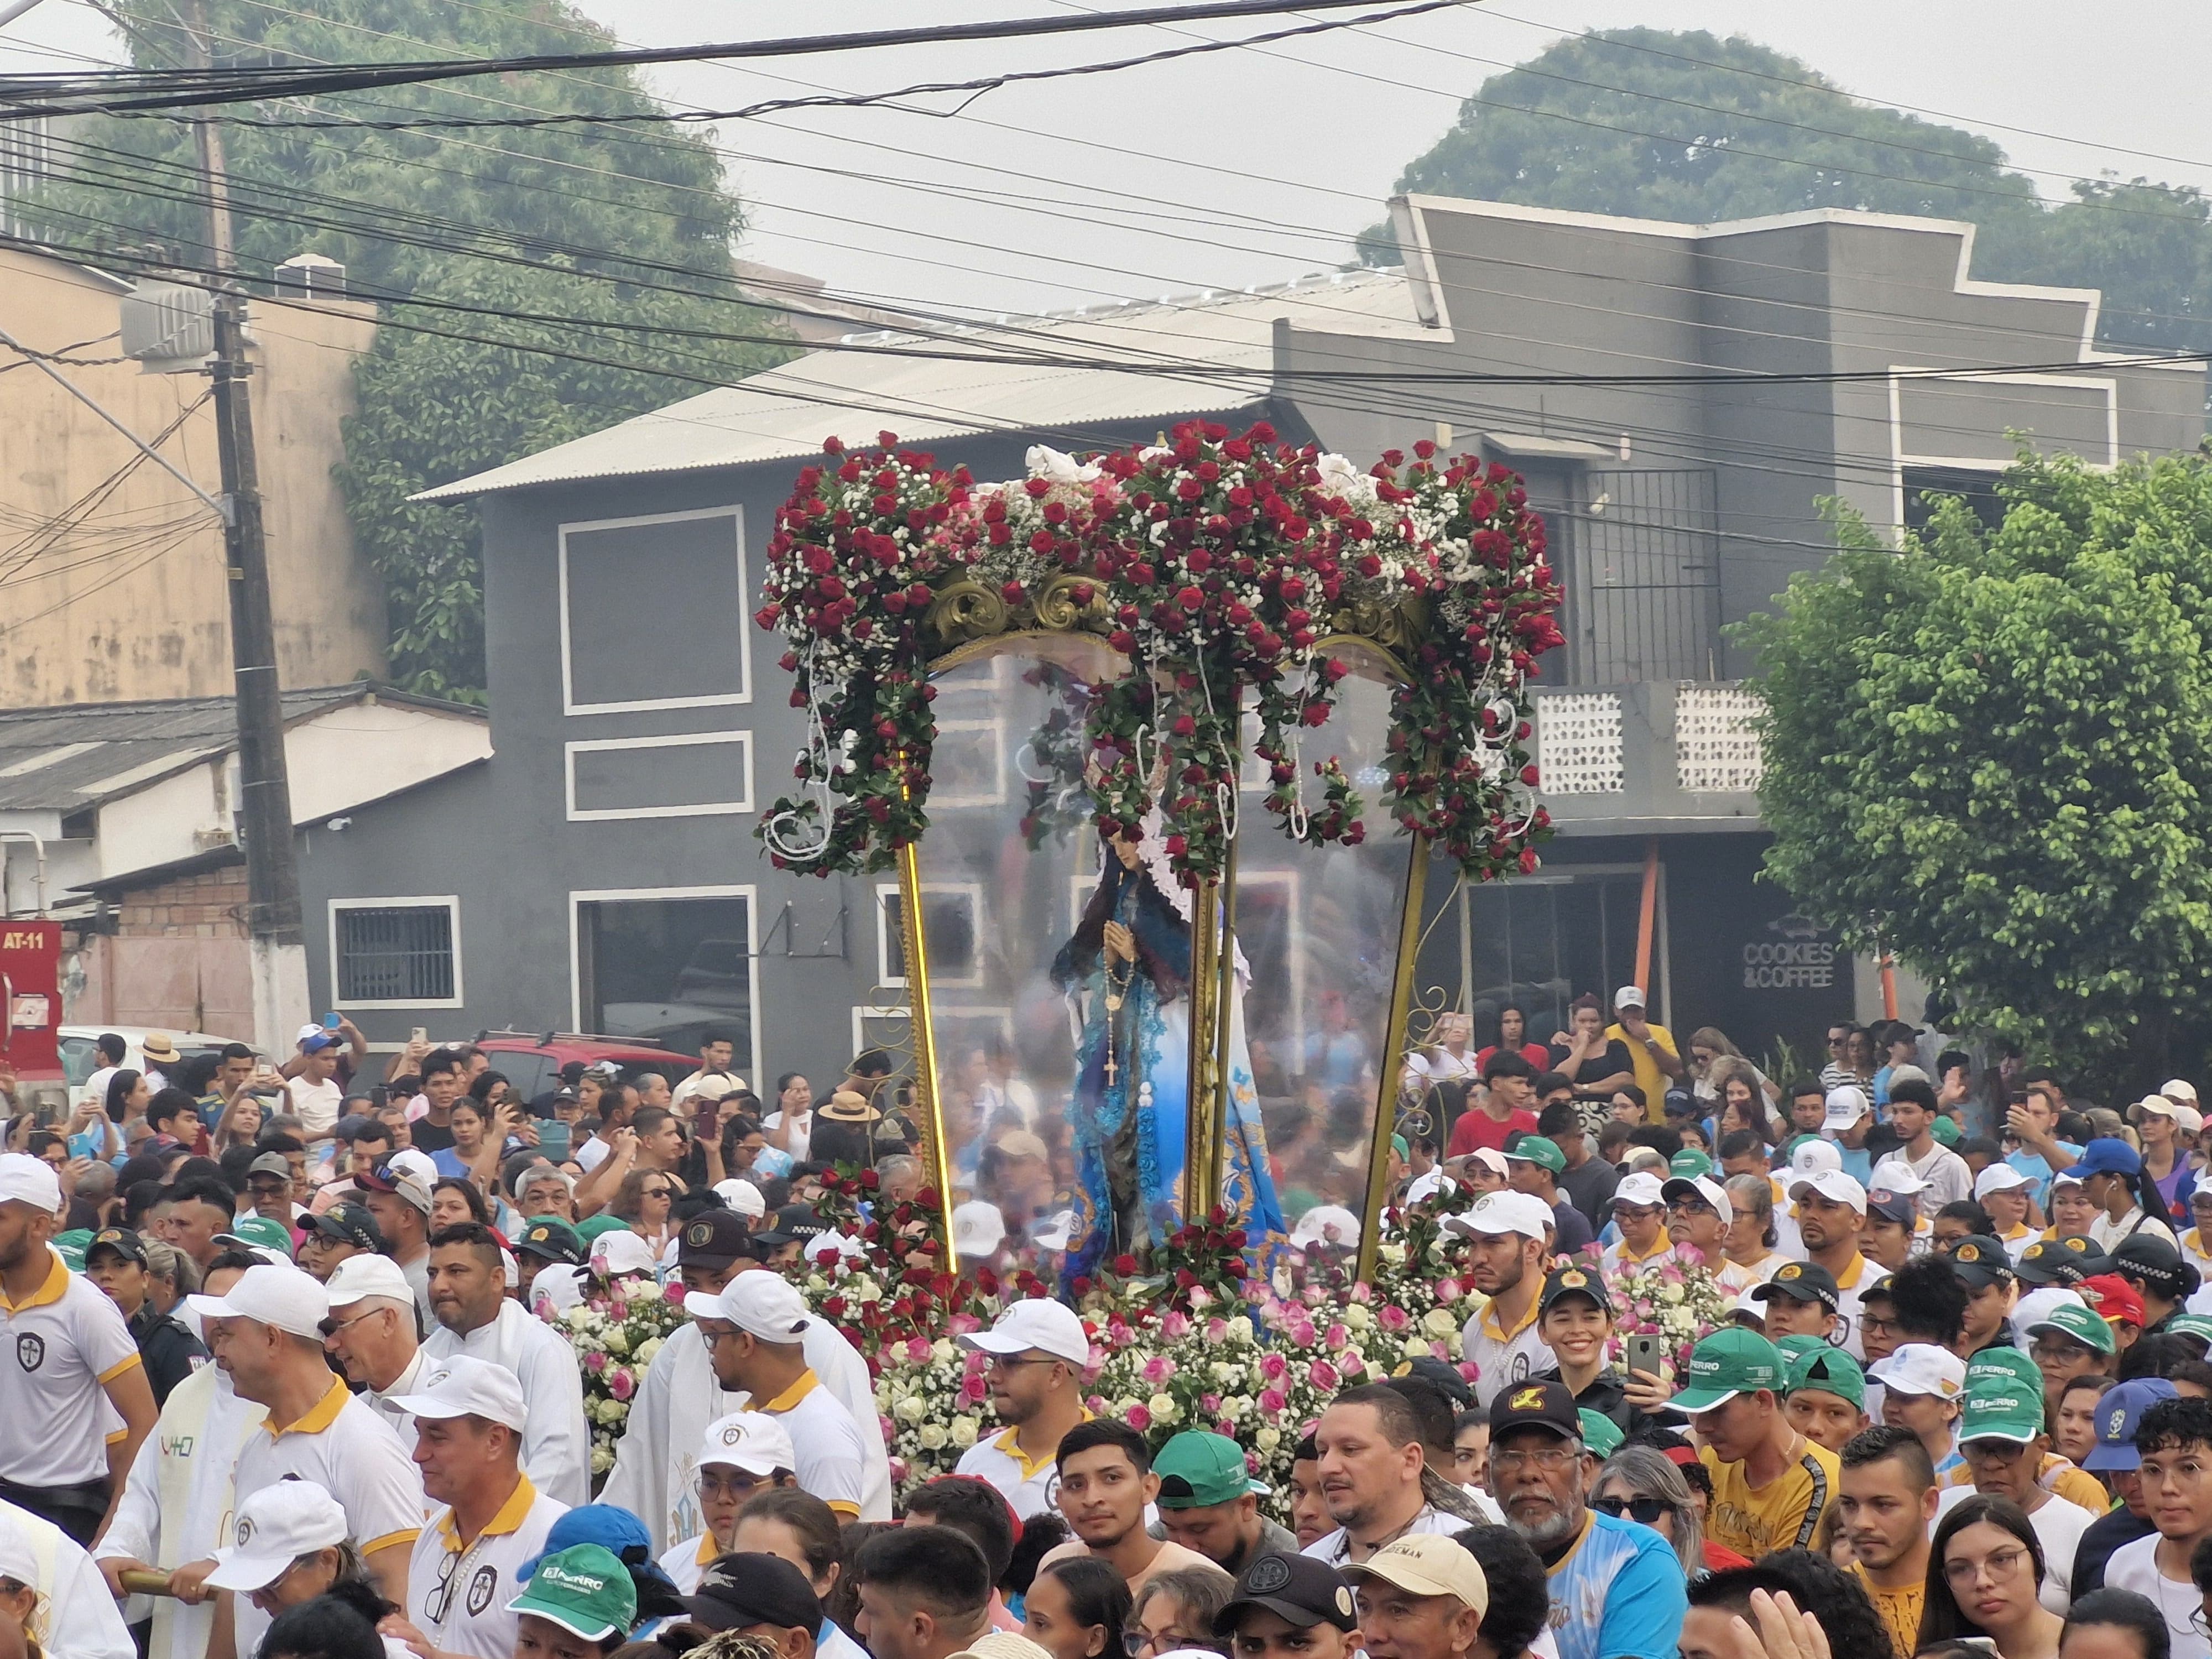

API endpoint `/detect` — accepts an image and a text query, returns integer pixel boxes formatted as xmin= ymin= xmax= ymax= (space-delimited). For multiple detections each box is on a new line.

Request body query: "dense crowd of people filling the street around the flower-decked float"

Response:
xmin=0 ymin=987 xmax=2212 ymax=1659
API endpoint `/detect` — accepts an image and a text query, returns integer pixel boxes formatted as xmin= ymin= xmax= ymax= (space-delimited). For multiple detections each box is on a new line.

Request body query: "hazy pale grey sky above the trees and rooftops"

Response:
xmin=0 ymin=0 xmax=2212 ymax=321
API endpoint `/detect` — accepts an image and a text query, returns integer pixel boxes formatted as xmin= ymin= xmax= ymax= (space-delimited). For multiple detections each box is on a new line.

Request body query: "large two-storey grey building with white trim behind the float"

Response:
xmin=303 ymin=199 xmax=2205 ymax=1093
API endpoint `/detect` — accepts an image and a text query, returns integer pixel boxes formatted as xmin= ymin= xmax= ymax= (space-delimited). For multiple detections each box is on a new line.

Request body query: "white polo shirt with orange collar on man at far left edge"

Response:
xmin=0 ymin=1250 xmax=142 ymax=1486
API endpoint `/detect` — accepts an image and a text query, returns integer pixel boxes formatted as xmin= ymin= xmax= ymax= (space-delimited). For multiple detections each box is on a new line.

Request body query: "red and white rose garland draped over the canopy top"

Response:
xmin=754 ymin=420 xmax=1562 ymax=885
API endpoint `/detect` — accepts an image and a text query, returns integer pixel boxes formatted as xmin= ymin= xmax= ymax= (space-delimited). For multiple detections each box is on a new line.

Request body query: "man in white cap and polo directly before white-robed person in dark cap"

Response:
xmin=684 ymin=1274 xmax=863 ymax=1520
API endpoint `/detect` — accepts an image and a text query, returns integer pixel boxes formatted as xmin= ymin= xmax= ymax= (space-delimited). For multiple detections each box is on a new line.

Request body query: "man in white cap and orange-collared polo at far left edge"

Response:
xmin=0 ymin=1152 xmax=155 ymax=1544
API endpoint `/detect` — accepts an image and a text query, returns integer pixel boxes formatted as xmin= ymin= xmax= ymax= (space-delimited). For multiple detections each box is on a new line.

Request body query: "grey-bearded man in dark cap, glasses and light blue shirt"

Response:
xmin=1491 ymin=1383 xmax=1688 ymax=1659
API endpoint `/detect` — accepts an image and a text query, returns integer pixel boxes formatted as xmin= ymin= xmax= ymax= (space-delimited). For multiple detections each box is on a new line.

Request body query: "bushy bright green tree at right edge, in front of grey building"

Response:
xmin=1745 ymin=456 xmax=2212 ymax=1097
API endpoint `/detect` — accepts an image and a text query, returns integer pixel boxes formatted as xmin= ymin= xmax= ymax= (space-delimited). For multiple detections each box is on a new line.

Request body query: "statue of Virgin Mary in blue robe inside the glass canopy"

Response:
xmin=1053 ymin=812 xmax=1283 ymax=1279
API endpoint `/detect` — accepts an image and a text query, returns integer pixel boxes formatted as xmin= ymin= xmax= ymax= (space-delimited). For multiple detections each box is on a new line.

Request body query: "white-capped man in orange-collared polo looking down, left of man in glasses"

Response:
xmin=170 ymin=1263 xmax=422 ymax=1655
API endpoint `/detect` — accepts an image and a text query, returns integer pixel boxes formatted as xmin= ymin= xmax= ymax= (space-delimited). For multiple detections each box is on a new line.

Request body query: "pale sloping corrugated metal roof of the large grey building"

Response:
xmin=414 ymin=270 xmax=1436 ymax=502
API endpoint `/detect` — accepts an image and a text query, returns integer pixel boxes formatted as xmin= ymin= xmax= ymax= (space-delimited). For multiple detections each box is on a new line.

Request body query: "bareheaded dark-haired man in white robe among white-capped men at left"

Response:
xmin=422 ymin=1221 xmax=593 ymax=1509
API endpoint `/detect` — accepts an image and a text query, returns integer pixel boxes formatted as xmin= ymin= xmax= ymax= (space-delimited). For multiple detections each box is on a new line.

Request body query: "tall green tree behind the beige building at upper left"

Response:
xmin=35 ymin=0 xmax=785 ymax=699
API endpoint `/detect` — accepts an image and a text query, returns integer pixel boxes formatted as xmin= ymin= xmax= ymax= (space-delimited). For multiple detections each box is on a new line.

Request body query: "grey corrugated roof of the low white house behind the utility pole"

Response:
xmin=0 ymin=681 xmax=482 ymax=812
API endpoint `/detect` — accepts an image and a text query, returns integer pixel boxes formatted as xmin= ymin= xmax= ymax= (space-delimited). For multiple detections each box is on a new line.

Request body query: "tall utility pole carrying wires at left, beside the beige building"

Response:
xmin=181 ymin=0 xmax=307 ymax=1060
